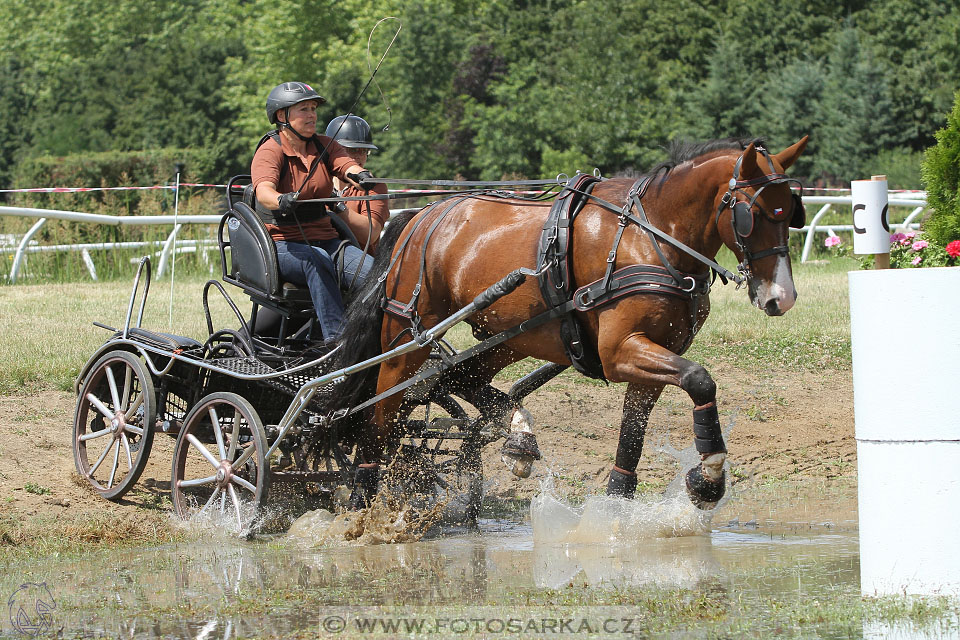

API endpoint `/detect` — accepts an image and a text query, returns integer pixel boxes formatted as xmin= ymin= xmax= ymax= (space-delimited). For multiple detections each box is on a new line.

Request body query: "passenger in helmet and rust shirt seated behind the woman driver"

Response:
xmin=326 ymin=115 xmax=390 ymax=253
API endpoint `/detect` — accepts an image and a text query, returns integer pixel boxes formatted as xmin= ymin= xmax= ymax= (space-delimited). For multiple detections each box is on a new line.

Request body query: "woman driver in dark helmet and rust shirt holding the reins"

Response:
xmin=250 ymin=82 xmax=373 ymax=340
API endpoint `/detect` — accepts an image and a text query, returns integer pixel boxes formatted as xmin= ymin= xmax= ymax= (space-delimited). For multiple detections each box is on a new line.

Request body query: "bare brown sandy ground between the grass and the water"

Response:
xmin=0 ymin=356 xmax=856 ymax=520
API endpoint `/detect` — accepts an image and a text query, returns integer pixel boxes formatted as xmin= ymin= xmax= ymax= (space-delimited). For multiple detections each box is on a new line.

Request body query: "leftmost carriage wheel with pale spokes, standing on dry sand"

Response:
xmin=73 ymin=351 xmax=157 ymax=500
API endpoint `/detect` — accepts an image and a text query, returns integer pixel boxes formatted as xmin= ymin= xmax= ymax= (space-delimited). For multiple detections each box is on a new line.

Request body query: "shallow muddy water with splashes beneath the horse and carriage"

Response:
xmin=0 ymin=488 xmax=869 ymax=638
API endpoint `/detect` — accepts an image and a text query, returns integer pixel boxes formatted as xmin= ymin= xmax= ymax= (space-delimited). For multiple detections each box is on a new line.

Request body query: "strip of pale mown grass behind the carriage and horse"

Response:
xmin=0 ymin=251 xmax=856 ymax=393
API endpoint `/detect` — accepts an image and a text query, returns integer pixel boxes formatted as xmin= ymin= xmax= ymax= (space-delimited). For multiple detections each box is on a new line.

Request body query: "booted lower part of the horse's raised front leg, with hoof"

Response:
xmin=687 ymin=401 xmax=727 ymax=509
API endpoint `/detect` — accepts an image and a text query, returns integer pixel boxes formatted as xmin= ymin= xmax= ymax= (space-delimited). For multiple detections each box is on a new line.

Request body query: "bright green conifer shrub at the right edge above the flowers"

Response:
xmin=921 ymin=91 xmax=960 ymax=246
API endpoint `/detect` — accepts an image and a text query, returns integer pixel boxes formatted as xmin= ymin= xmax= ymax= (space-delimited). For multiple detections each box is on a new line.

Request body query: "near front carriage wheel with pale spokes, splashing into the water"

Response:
xmin=170 ymin=392 xmax=269 ymax=534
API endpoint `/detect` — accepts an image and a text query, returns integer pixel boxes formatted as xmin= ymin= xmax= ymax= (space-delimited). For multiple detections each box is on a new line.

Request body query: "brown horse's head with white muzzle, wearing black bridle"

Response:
xmin=716 ymin=136 xmax=808 ymax=316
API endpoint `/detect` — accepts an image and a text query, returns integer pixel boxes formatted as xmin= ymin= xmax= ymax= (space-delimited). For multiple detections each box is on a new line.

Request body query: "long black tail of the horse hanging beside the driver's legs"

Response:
xmin=330 ymin=210 xmax=418 ymax=410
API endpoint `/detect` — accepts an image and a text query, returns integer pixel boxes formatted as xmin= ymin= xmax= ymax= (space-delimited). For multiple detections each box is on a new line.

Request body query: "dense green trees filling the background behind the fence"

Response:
xmin=0 ymin=0 xmax=960 ymax=187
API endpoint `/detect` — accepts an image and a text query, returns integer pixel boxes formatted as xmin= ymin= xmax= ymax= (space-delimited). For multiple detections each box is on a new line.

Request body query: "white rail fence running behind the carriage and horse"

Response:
xmin=0 ymin=194 xmax=927 ymax=282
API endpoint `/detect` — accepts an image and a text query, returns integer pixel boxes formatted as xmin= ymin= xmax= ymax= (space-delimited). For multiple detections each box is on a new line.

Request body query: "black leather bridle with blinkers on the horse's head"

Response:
xmin=715 ymin=145 xmax=806 ymax=278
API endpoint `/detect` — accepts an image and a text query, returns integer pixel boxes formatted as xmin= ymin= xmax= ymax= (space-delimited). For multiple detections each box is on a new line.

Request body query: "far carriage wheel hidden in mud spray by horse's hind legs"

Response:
xmin=409 ymin=395 xmax=483 ymax=522
